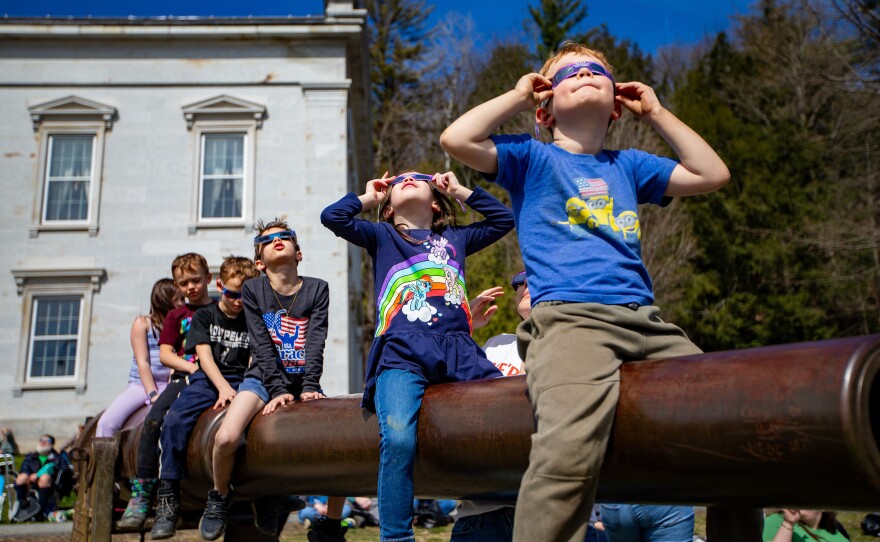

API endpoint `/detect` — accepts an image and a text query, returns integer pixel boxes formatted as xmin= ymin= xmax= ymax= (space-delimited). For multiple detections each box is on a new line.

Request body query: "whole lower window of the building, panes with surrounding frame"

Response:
xmin=12 ymin=269 xmax=107 ymax=395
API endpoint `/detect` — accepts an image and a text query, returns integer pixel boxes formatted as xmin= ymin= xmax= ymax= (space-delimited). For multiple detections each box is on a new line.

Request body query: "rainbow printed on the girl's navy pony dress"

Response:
xmin=376 ymin=254 xmax=472 ymax=337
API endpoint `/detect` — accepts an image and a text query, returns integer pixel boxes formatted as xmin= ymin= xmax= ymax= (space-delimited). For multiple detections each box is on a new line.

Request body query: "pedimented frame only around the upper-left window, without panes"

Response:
xmin=28 ymin=96 xmax=116 ymax=238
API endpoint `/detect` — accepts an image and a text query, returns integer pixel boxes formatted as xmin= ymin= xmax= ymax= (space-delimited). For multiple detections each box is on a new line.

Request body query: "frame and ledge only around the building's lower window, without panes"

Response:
xmin=12 ymin=268 xmax=107 ymax=397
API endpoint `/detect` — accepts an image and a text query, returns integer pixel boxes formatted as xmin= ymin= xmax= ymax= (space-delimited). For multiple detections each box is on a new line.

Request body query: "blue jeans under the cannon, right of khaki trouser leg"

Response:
xmin=600 ymin=504 xmax=694 ymax=542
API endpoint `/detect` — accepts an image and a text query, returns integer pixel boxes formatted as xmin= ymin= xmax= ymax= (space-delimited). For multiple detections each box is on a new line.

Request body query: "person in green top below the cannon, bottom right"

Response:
xmin=764 ymin=509 xmax=849 ymax=542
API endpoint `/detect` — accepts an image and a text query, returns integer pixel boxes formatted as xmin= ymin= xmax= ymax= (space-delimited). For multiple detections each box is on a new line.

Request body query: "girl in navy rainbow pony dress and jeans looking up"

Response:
xmin=321 ymin=172 xmax=513 ymax=541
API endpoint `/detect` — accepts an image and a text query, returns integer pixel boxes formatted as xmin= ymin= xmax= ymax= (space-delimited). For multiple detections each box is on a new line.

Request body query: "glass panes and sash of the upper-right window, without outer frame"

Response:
xmin=199 ymin=133 xmax=247 ymax=220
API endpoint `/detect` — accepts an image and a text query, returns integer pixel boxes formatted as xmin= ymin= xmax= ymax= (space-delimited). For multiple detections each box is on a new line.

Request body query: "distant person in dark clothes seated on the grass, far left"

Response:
xmin=12 ymin=435 xmax=69 ymax=523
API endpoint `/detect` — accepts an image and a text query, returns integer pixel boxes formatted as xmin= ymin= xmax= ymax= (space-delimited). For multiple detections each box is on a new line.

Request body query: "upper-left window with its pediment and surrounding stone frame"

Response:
xmin=29 ymin=96 xmax=116 ymax=237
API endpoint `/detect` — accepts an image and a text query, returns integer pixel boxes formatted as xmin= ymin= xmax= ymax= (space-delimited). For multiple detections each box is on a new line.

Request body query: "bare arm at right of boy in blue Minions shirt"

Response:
xmin=616 ymin=82 xmax=730 ymax=197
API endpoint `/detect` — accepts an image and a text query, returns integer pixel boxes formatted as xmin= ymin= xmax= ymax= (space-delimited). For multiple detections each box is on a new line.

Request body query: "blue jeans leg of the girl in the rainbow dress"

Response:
xmin=375 ymin=369 xmax=428 ymax=542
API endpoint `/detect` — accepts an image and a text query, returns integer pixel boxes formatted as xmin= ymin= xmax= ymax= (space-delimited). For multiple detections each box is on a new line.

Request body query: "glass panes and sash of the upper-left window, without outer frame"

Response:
xmin=43 ymin=135 xmax=95 ymax=223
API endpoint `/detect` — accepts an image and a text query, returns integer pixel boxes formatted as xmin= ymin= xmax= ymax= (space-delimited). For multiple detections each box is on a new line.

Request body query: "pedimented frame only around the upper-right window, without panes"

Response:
xmin=183 ymin=95 xmax=266 ymax=235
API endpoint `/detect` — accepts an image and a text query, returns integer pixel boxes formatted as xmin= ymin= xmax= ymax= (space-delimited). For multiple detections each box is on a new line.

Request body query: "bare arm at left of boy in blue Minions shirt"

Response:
xmin=440 ymin=73 xmax=553 ymax=174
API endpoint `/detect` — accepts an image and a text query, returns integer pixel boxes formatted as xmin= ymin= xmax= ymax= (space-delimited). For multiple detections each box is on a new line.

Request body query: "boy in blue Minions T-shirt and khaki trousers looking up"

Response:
xmin=440 ymin=42 xmax=730 ymax=542
